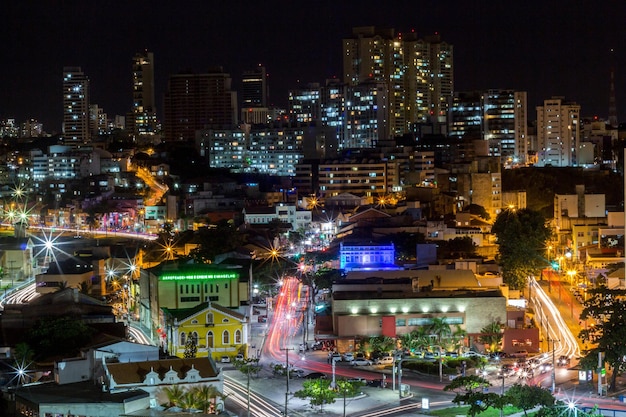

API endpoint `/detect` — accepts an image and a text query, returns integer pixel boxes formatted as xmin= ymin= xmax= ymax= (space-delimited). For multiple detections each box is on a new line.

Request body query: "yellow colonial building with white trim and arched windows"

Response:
xmin=157 ymin=301 xmax=250 ymax=361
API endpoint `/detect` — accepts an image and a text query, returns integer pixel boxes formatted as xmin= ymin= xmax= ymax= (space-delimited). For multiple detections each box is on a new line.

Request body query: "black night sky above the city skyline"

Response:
xmin=0 ymin=0 xmax=626 ymax=132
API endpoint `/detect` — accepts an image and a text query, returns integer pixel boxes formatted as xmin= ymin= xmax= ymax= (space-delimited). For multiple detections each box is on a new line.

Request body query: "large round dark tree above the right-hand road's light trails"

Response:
xmin=491 ymin=209 xmax=552 ymax=290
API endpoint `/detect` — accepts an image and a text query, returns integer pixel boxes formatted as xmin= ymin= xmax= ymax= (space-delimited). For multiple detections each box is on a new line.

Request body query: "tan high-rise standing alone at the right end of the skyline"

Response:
xmin=537 ymin=97 xmax=580 ymax=167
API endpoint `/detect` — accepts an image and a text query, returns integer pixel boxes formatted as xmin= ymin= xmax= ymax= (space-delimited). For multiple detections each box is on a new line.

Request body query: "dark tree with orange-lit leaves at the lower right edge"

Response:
xmin=580 ymin=286 xmax=626 ymax=391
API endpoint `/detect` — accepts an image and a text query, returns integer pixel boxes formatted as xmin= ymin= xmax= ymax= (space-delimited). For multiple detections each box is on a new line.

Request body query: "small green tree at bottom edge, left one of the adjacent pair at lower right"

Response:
xmin=443 ymin=375 xmax=500 ymax=417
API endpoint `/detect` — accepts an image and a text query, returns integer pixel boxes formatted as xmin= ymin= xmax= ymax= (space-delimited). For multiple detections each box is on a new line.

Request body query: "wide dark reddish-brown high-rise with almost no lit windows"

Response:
xmin=163 ymin=67 xmax=237 ymax=141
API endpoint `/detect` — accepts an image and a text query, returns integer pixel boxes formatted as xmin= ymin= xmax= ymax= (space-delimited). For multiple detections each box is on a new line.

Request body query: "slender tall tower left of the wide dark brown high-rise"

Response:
xmin=126 ymin=51 xmax=157 ymax=136
